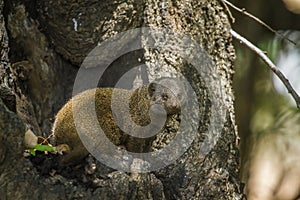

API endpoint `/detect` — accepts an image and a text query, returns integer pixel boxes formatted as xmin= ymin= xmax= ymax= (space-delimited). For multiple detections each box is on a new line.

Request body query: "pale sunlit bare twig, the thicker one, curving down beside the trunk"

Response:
xmin=230 ymin=29 xmax=300 ymax=109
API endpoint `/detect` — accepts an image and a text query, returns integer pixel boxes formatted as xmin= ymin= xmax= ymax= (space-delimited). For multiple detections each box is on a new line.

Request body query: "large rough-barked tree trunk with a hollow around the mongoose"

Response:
xmin=0 ymin=0 xmax=243 ymax=199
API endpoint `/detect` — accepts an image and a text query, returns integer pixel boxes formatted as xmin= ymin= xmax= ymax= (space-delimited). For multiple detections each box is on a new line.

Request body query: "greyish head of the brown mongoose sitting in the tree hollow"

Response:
xmin=148 ymin=78 xmax=187 ymax=114
